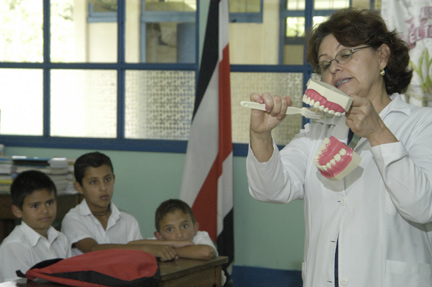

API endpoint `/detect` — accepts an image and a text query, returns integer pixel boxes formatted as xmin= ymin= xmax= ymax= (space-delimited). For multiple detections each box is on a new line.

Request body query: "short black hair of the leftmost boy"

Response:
xmin=11 ymin=170 xmax=57 ymax=209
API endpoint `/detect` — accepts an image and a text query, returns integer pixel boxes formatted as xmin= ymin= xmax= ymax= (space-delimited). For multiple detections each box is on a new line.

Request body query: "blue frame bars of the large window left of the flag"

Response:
xmin=0 ymin=0 xmax=199 ymax=153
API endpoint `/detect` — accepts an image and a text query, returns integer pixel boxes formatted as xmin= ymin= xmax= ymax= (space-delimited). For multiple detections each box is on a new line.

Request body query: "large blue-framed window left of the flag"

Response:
xmin=0 ymin=0 xmax=197 ymax=152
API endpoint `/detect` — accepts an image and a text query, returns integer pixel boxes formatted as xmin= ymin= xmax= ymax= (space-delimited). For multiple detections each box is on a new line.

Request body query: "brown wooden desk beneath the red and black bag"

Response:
xmin=0 ymin=256 xmax=228 ymax=287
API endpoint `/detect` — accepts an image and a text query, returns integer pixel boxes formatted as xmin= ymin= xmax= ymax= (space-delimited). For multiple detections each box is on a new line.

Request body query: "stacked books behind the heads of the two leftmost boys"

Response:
xmin=12 ymin=156 xmax=76 ymax=194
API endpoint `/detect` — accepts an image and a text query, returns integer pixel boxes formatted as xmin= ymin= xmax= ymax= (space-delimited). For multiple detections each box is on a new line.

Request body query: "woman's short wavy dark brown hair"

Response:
xmin=307 ymin=8 xmax=412 ymax=95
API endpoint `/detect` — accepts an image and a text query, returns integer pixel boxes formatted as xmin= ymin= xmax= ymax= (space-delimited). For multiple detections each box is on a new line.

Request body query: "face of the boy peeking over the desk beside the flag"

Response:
xmin=155 ymin=209 xmax=198 ymax=241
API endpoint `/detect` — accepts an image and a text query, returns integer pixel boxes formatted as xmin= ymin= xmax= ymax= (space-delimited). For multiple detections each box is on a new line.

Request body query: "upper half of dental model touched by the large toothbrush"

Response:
xmin=302 ymin=79 xmax=352 ymax=116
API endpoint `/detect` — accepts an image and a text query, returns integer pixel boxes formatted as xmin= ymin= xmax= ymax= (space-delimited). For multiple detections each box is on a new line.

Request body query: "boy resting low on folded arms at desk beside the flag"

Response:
xmin=131 ymin=199 xmax=217 ymax=260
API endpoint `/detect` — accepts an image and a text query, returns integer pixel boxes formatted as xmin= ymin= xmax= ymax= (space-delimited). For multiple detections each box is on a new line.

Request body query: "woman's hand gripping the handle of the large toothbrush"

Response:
xmin=250 ymin=93 xmax=292 ymax=136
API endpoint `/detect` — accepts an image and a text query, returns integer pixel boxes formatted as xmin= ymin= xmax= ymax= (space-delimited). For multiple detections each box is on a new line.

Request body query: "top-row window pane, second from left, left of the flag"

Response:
xmin=51 ymin=0 xmax=117 ymax=63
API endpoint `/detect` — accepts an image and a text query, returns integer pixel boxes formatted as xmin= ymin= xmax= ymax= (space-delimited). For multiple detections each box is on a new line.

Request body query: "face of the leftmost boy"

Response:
xmin=13 ymin=188 xmax=57 ymax=237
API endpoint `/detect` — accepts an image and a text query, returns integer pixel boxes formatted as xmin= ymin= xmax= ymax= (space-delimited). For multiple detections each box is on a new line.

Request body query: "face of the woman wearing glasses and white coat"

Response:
xmin=318 ymin=34 xmax=387 ymax=100
